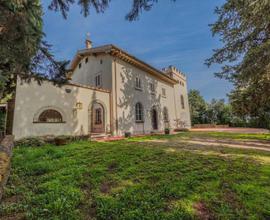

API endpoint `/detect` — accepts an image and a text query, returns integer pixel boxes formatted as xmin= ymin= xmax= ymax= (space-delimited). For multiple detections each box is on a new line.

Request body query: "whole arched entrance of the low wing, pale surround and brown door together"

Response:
xmin=88 ymin=100 xmax=107 ymax=133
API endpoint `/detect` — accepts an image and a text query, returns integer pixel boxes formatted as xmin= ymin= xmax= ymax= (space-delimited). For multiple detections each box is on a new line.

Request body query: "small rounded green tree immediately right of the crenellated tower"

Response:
xmin=188 ymin=89 xmax=207 ymax=125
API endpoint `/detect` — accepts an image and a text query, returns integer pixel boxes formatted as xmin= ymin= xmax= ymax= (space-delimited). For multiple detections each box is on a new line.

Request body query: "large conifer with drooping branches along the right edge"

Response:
xmin=206 ymin=0 xmax=270 ymax=128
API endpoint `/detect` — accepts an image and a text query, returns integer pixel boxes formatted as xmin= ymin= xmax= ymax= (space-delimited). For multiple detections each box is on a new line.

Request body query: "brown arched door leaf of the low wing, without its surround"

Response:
xmin=91 ymin=103 xmax=105 ymax=133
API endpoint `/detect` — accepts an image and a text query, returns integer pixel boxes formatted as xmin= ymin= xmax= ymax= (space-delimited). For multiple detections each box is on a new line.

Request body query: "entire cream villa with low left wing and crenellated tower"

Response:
xmin=11 ymin=36 xmax=191 ymax=139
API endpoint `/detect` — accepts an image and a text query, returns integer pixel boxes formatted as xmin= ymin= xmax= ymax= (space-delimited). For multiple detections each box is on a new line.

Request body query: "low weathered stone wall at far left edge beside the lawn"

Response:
xmin=0 ymin=135 xmax=14 ymax=201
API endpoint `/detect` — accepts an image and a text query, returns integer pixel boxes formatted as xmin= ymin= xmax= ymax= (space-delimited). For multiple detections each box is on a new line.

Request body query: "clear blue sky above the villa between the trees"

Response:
xmin=42 ymin=0 xmax=232 ymax=100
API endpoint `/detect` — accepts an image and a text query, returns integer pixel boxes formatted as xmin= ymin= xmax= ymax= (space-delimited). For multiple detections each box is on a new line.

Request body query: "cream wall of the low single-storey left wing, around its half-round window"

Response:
xmin=13 ymin=80 xmax=110 ymax=139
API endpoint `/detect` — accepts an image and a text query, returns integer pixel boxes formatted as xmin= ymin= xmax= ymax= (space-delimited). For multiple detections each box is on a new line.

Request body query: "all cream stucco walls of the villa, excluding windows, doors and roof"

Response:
xmin=13 ymin=49 xmax=190 ymax=138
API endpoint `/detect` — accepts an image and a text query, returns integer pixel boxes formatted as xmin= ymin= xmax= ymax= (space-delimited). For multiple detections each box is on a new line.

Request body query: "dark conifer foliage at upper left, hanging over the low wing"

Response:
xmin=0 ymin=0 xmax=67 ymax=98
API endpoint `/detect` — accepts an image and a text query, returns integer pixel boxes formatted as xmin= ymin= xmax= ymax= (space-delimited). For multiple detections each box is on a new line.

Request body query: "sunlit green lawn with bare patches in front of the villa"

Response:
xmin=0 ymin=133 xmax=270 ymax=219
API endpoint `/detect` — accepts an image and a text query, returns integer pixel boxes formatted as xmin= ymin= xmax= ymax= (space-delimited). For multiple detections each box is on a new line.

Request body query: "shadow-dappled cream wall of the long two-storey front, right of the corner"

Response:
xmin=112 ymin=59 xmax=190 ymax=135
